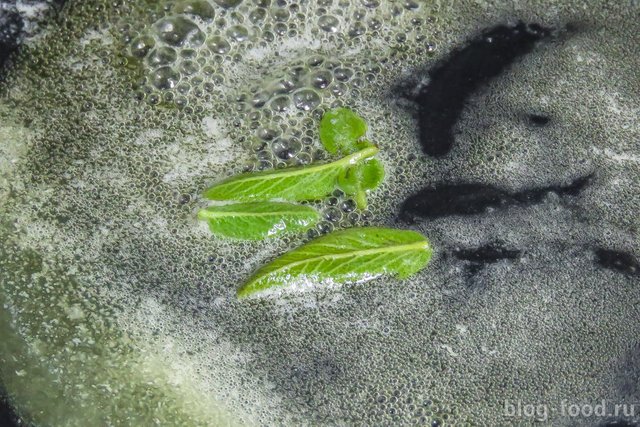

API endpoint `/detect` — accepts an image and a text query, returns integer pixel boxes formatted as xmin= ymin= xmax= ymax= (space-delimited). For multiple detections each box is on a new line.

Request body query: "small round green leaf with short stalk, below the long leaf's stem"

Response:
xmin=338 ymin=159 xmax=384 ymax=209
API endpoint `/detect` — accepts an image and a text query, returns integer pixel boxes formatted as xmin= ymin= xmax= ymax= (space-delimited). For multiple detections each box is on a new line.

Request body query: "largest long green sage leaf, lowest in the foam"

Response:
xmin=238 ymin=227 xmax=432 ymax=298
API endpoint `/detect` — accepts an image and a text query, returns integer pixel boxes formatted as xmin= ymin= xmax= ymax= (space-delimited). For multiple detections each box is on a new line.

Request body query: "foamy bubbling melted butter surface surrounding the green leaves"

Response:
xmin=0 ymin=0 xmax=640 ymax=426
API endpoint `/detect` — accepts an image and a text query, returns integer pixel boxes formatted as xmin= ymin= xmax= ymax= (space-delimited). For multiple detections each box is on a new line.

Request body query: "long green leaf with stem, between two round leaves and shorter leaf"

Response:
xmin=204 ymin=146 xmax=378 ymax=202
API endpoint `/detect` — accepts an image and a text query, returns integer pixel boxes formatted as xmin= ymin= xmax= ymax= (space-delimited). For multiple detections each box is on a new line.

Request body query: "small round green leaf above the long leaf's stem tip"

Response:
xmin=320 ymin=108 xmax=367 ymax=154
